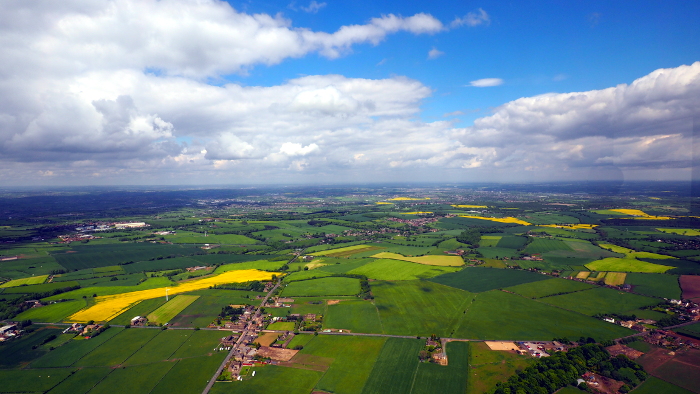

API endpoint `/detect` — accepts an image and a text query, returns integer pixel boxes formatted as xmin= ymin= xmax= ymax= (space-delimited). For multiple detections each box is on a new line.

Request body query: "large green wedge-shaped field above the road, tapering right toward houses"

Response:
xmin=452 ymin=290 xmax=634 ymax=341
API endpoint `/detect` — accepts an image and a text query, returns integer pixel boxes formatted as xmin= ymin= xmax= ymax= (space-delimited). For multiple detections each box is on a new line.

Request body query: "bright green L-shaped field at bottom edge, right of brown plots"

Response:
xmin=299 ymin=335 xmax=386 ymax=394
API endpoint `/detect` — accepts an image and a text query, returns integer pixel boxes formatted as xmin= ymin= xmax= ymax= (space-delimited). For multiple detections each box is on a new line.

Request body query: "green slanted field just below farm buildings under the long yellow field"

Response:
xmin=75 ymin=329 xmax=159 ymax=367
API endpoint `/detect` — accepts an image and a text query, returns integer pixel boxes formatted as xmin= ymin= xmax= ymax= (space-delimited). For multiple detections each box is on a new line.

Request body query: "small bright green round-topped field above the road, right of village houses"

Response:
xmin=323 ymin=300 xmax=383 ymax=334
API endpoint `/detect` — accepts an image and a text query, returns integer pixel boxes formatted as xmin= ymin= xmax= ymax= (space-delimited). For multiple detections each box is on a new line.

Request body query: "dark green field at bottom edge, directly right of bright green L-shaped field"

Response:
xmin=362 ymin=338 xmax=425 ymax=394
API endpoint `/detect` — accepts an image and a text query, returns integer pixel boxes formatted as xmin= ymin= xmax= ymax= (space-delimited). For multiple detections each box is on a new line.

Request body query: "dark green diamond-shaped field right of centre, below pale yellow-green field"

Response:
xmin=430 ymin=267 xmax=550 ymax=293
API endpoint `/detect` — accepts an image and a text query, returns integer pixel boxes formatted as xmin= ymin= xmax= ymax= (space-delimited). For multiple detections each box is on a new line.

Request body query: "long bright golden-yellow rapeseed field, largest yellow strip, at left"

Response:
xmin=67 ymin=269 xmax=273 ymax=322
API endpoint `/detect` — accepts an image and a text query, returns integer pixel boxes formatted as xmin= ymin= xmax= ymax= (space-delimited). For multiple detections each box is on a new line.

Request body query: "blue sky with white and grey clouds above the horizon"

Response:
xmin=0 ymin=0 xmax=700 ymax=186
